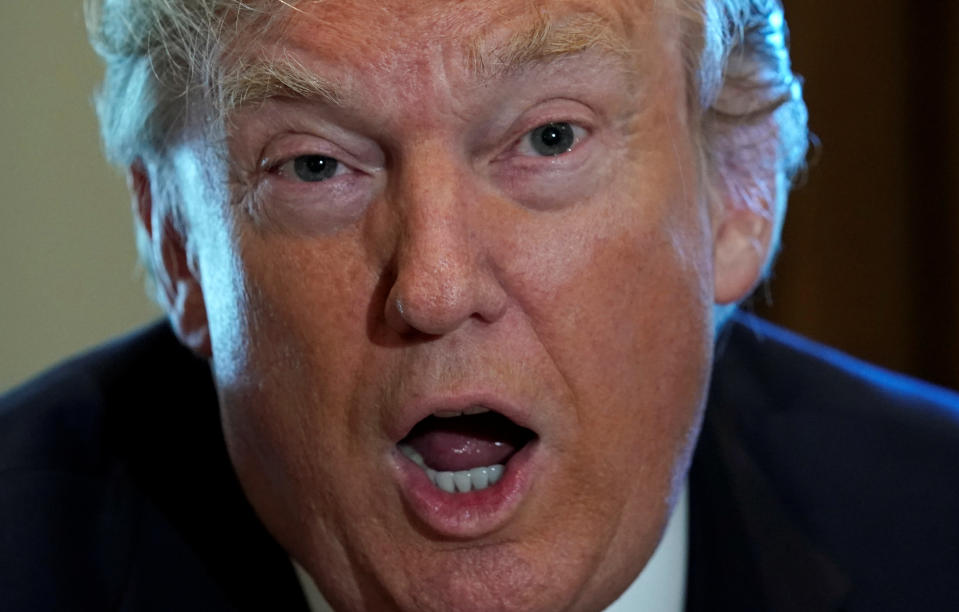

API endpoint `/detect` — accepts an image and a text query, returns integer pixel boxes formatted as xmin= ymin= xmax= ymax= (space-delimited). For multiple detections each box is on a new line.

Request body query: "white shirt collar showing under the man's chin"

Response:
xmin=293 ymin=485 xmax=689 ymax=612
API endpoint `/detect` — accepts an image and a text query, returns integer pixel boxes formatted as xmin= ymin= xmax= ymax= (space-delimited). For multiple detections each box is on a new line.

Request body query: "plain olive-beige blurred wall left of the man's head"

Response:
xmin=0 ymin=0 xmax=157 ymax=391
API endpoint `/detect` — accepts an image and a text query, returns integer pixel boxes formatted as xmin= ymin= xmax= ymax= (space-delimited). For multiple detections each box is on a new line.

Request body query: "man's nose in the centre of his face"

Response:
xmin=385 ymin=155 xmax=507 ymax=336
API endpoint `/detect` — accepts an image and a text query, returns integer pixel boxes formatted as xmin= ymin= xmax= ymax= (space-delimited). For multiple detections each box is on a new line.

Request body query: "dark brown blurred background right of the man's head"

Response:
xmin=753 ymin=0 xmax=959 ymax=388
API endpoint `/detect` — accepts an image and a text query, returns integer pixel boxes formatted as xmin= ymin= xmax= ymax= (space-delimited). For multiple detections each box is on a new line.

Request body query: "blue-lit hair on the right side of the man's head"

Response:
xmin=665 ymin=0 xmax=810 ymax=282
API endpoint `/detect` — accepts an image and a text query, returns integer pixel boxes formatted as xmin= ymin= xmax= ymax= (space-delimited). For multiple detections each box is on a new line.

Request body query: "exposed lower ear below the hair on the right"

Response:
xmin=713 ymin=206 xmax=772 ymax=304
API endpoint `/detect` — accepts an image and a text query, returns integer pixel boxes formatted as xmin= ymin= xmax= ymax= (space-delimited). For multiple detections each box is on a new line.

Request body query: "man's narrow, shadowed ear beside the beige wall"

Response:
xmin=129 ymin=160 xmax=212 ymax=358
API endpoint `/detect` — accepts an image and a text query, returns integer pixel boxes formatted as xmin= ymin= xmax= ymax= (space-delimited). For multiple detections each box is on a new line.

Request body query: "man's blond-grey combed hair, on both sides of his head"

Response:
xmin=86 ymin=0 xmax=809 ymax=294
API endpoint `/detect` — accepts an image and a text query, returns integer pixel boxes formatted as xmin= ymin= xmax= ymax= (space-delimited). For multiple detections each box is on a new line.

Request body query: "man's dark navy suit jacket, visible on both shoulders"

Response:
xmin=0 ymin=316 xmax=959 ymax=612
